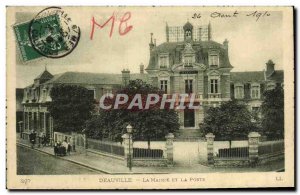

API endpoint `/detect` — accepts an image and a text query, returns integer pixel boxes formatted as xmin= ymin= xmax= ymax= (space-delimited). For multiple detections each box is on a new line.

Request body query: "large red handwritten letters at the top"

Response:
xmin=90 ymin=12 xmax=133 ymax=40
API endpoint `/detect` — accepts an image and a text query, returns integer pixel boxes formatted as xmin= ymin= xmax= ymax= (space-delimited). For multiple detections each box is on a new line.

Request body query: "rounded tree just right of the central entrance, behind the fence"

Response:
xmin=202 ymin=100 xmax=257 ymax=141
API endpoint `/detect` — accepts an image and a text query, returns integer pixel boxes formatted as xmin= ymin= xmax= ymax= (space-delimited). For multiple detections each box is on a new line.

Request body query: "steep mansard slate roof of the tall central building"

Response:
xmin=146 ymin=41 xmax=232 ymax=70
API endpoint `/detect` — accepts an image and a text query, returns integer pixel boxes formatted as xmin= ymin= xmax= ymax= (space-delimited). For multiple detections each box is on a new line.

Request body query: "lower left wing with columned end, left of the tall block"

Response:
xmin=17 ymin=67 xmax=148 ymax=141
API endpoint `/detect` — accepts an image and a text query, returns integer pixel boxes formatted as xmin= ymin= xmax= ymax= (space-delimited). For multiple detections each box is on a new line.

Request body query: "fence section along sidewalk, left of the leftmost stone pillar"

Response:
xmin=88 ymin=139 xmax=125 ymax=156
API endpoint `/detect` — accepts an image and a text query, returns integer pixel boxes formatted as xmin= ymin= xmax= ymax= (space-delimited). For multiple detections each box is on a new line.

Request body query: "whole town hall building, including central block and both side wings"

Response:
xmin=17 ymin=22 xmax=283 ymax=138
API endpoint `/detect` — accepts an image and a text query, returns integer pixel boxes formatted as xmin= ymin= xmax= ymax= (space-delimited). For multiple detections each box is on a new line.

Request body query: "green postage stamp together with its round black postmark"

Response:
xmin=14 ymin=7 xmax=80 ymax=61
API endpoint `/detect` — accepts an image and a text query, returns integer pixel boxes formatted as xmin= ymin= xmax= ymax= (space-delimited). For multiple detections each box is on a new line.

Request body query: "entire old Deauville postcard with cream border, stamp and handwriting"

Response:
xmin=6 ymin=6 xmax=295 ymax=189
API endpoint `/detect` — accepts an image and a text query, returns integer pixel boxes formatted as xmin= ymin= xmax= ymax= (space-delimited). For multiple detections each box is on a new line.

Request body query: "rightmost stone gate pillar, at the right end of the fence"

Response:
xmin=248 ymin=132 xmax=260 ymax=163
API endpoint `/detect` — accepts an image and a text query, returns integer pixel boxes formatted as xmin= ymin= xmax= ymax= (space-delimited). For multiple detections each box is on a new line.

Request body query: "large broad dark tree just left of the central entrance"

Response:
xmin=87 ymin=80 xmax=179 ymax=148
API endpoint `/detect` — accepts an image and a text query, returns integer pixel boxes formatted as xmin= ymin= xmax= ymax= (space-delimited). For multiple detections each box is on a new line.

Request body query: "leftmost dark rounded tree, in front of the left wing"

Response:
xmin=48 ymin=85 xmax=94 ymax=132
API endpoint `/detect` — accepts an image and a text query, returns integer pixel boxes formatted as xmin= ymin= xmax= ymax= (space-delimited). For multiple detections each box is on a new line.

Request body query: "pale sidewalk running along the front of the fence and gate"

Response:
xmin=17 ymin=139 xmax=284 ymax=174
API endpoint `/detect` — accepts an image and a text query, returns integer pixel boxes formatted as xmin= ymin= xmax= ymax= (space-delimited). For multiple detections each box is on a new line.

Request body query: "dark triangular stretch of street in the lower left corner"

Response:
xmin=17 ymin=146 xmax=103 ymax=175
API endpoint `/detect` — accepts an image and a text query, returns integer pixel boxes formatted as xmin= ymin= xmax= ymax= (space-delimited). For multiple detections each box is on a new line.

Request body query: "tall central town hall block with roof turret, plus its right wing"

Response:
xmin=146 ymin=22 xmax=283 ymax=137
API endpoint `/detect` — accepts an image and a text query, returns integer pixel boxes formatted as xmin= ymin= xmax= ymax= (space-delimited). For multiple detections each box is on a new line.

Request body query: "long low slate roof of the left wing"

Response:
xmin=46 ymin=72 xmax=148 ymax=85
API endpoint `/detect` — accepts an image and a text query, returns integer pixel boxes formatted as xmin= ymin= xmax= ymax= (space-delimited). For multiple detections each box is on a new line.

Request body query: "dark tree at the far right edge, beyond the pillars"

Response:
xmin=261 ymin=86 xmax=284 ymax=139
